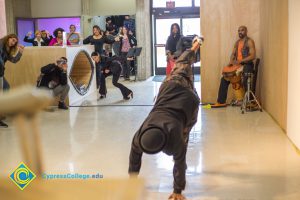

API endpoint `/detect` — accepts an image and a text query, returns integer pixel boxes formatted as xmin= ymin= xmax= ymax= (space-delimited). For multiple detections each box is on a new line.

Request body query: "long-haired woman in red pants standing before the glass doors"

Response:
xmin=166 ymin=23 xmax=182 ymax=75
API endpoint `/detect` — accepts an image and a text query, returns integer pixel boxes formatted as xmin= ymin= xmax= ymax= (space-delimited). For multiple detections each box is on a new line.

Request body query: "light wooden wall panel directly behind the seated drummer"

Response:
xmin=200 ymin=0 xmax=260 ymax=102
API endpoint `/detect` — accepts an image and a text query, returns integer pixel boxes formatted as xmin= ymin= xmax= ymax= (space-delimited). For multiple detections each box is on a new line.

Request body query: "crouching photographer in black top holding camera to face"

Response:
xmin=37 ymin=57 xmax=70 ymax=110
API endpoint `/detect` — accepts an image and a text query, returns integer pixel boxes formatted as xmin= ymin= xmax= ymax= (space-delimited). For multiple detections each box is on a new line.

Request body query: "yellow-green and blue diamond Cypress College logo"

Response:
xmin=9 ymin=162 xmax=36 ymax=190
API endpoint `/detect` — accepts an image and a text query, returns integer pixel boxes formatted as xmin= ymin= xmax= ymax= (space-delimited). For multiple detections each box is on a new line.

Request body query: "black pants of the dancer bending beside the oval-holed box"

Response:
xmin=99 ymin=67 xmax=132 ymax=98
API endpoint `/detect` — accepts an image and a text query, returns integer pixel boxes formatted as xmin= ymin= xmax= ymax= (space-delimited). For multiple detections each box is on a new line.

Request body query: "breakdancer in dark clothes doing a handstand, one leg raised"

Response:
xmin=128 ymin=37 xmax=202 ymax=200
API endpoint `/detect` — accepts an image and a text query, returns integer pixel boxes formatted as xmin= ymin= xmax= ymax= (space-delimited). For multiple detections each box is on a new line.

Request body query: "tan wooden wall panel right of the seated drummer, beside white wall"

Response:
xmin=259 ymin=0 xmax=288 ymax=130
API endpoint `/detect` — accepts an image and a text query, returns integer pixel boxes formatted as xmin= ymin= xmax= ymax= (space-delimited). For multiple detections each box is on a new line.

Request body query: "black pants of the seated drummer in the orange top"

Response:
xmin=217 ymin=63 xmax=254 ymax=104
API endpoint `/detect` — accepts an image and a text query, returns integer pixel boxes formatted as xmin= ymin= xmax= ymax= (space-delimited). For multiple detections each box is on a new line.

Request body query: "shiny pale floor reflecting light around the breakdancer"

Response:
xmin=0 ymin=81 xmax=300 ymax=200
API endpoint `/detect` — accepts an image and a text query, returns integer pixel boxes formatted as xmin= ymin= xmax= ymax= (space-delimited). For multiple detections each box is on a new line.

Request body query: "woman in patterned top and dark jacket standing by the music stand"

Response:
xmin=120 ymin=26 xmax=137 ymax=80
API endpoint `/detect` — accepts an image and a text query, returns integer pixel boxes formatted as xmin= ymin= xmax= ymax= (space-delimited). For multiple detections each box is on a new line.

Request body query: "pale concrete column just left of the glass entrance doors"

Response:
xmin=135 ymin=0 xmax=152 ymax=80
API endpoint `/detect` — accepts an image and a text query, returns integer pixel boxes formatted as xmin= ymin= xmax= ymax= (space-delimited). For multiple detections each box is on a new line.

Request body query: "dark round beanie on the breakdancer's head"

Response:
xmin=140 ymin=127 xmax=166 ymax=154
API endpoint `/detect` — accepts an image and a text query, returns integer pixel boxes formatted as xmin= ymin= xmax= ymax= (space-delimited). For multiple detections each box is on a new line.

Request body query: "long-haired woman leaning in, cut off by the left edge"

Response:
xmin=0 ymin=34 xmax=24 ymax=128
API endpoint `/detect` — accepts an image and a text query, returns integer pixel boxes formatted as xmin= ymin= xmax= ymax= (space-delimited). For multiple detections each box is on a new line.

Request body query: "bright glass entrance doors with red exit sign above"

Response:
xmin=150 ymin=0 xmax=201 ymax=75
